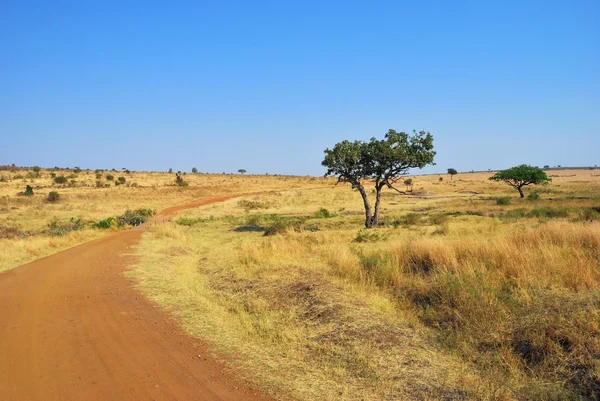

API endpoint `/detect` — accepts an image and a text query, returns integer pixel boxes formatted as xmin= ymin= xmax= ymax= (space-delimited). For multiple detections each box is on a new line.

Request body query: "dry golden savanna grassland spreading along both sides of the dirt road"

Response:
xmin=0 ymin=165 xmax=600 ymax=400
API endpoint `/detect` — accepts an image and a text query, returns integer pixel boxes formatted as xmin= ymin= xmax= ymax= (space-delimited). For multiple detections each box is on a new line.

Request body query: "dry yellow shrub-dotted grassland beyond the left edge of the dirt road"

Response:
xmin=0 ymin=166 xmax=329 ymax=271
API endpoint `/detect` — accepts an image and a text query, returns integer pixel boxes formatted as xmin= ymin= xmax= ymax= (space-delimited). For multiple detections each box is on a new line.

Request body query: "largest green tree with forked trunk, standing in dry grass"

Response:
xmin=321 ymin=129 xmax=435 ymax=228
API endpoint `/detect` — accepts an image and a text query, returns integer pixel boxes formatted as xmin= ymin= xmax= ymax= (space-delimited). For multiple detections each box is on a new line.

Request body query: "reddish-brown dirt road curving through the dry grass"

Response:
xmin=0 ymin=196 xmax=272 ymax=401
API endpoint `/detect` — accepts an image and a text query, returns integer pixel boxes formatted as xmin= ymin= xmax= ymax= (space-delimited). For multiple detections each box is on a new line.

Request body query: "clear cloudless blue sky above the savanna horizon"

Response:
xmin=0 ymin=0 xmax=600 ymax=175
